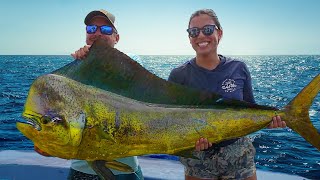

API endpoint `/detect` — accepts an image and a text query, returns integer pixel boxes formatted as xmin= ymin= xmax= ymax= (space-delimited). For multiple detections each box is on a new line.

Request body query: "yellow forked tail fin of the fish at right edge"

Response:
xmin=284 ymin=74 xmax=320 ymax=150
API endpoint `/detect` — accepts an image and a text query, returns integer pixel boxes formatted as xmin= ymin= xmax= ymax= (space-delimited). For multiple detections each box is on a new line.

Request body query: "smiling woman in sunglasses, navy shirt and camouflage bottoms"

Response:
xmin=169 ymin=9 xmax=286 ymax=180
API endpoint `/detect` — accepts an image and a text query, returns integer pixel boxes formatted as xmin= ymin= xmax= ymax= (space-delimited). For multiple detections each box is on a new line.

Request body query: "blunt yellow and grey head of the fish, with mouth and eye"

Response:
xmin=17 ymin=74 xmax=82 ymax=156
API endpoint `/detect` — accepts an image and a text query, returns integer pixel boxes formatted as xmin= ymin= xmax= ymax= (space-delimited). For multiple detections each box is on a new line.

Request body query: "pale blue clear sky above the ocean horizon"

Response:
xmin=0 ymin=0 xmax=320 ymax=55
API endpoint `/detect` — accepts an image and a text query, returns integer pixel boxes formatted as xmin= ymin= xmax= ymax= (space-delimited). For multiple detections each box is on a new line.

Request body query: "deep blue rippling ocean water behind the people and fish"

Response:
xmin=0 ymin=55 xmax=320 ymax=179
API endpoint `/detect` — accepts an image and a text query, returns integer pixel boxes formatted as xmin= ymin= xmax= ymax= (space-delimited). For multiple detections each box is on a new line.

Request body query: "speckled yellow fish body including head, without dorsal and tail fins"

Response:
xmin=17 ymin=74 xmax=320 ymax=161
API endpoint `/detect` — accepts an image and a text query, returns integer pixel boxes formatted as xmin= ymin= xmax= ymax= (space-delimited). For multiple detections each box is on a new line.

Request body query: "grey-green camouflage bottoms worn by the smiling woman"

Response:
xmin=180 ymin=137 xmax=256 ymax=179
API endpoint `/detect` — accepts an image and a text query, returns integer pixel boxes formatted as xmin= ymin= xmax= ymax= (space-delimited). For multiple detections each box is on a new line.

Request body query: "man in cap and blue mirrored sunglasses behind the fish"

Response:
xmin=68 ymin=10 xmax=143 ymax=180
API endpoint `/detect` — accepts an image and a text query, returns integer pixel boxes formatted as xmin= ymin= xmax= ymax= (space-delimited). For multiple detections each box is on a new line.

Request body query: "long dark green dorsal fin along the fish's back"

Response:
xmin=52 ymin=39 xmax=278 ymax=109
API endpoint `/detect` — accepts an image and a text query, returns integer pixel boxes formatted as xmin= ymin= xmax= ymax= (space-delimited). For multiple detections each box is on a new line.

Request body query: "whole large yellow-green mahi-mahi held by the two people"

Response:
xmin=17 ymin=41 xmax=320 ymax=179
